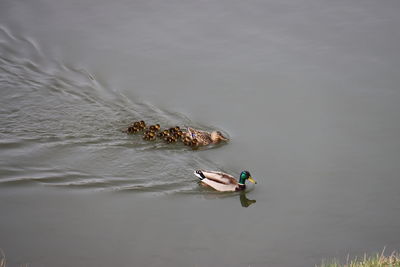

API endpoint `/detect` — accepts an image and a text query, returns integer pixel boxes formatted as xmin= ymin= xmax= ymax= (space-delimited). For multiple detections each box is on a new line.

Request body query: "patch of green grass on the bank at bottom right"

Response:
xmin=316 ymin=251 xmax=400 ymax=267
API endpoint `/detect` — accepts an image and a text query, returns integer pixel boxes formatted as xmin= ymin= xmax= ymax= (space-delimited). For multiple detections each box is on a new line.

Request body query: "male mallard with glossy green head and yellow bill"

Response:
xmin=194 ymin=170 xmax=257 ymax=192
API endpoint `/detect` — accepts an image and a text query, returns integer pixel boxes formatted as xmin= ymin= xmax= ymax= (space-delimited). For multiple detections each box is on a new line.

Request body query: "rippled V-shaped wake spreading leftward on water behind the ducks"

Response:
xmin=0 ymin=26 xmax=228 ymax=193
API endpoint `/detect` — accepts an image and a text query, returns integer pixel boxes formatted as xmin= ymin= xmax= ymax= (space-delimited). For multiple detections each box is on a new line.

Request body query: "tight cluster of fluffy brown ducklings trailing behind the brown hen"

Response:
xmin=125 ymin=120 xmax=198 ymax=148
